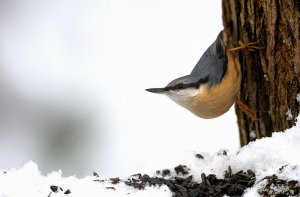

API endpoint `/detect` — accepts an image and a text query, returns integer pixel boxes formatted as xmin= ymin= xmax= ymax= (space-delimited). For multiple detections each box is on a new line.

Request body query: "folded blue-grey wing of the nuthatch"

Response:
xmin=191 ymin=31 xmax=227 ymax=87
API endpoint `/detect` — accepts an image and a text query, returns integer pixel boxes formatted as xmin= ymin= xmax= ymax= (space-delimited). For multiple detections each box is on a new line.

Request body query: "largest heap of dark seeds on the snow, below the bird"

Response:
xmin=125 ymin=165 xmax=255 ymax=197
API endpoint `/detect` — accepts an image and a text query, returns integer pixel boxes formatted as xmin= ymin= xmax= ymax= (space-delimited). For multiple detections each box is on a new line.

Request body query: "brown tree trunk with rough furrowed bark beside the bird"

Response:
xmin=222 ymin=0 xmax=300 ymax=145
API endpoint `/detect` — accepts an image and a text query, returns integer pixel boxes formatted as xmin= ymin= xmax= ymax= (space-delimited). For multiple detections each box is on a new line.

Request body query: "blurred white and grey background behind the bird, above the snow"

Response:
xmin=0 ymin=0 xmax=239 ymax=177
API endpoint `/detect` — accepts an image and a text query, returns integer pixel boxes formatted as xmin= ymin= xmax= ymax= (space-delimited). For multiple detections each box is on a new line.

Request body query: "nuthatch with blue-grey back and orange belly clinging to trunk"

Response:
xmin=146 ymin=31 xmax=241 ymax=119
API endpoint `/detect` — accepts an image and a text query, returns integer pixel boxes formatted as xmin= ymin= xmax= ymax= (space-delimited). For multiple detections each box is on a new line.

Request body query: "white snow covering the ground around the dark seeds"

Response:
xmin=0 ymin=117 xmax=300 ymax=197
